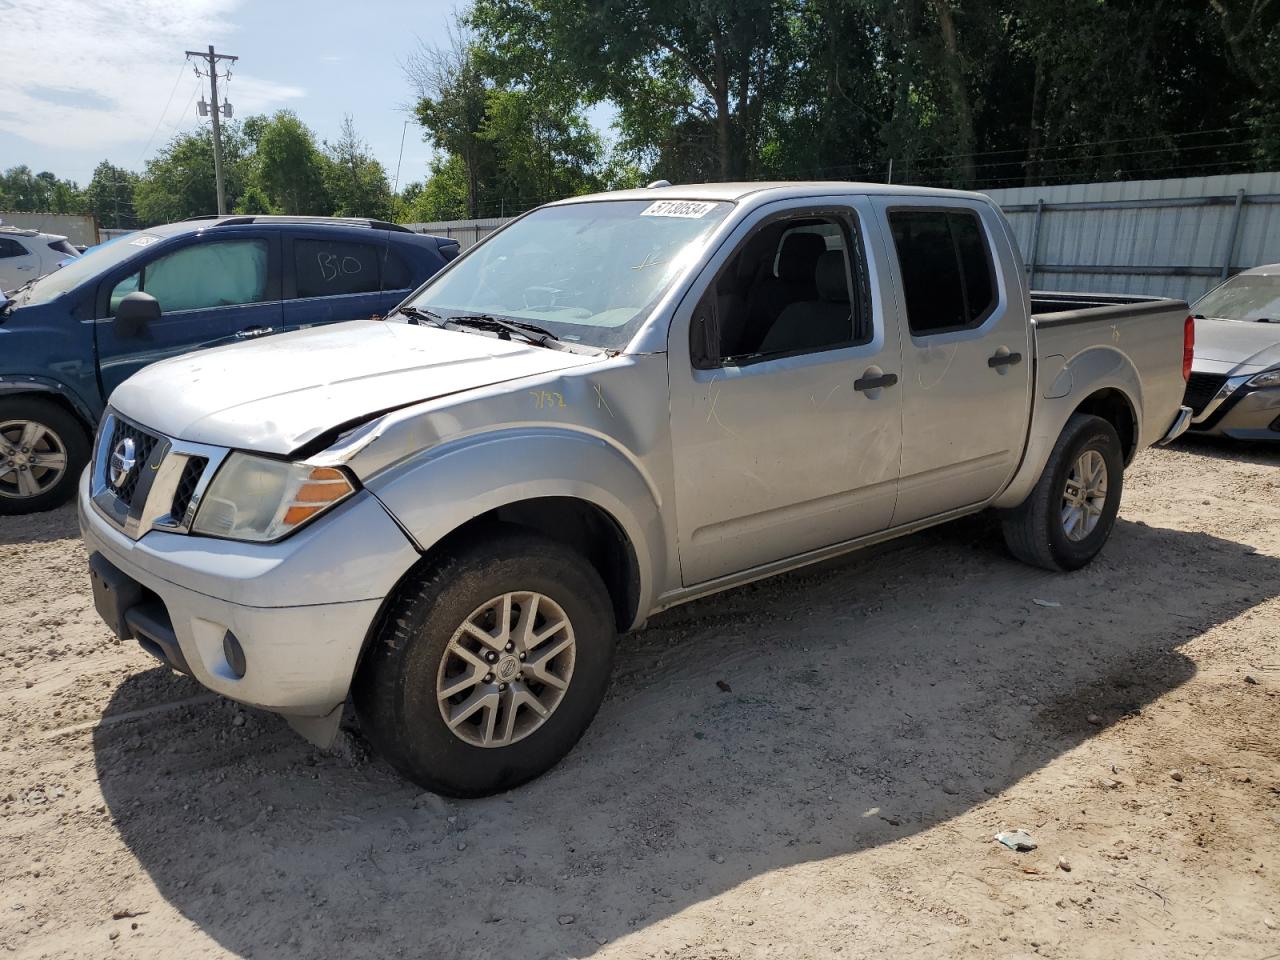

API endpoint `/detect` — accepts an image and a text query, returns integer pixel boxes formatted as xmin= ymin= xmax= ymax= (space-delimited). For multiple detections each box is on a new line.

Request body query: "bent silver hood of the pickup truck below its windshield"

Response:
xmin=110 ymin=320 xmax=602 ymax=454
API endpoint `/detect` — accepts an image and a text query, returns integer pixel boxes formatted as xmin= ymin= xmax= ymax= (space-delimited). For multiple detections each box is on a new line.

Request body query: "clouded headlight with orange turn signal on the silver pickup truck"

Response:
xmin=191 ymin=453 xmax=356 ymax=541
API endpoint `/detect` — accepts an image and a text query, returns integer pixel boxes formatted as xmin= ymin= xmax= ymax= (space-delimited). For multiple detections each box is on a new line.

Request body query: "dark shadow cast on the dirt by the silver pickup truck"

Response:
xmin=93 ymin=518 xmax=1280 ymax=957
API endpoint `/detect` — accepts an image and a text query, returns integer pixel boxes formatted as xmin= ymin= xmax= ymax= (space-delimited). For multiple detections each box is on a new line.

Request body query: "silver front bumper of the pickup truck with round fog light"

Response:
xmin=79 ymin=476 xmax=419 ymax=726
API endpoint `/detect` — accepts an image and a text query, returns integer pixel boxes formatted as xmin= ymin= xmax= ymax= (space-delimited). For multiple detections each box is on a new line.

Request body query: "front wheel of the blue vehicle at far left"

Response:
xmin=0 ymin=397 xmax=90 ymax=515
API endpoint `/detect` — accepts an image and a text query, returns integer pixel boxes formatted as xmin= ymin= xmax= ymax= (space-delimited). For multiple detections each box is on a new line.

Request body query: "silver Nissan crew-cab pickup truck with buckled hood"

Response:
xmin=79 ymin=183 xmax=1194 ymax=796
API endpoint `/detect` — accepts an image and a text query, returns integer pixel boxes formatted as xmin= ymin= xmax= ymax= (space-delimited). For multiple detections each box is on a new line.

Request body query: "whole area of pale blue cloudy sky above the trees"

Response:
xmin=0 ymin=0 xmax=608 ymax=186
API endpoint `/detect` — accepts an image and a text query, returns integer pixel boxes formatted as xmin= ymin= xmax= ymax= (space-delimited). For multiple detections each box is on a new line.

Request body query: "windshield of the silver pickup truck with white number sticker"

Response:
xmin=412 ymin=200 xmax=732 ymax=349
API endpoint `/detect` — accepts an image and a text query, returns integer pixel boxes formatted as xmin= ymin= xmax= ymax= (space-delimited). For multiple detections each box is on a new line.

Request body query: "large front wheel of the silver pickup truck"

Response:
xmin=353 ymin=531 xmax=616 ymax=796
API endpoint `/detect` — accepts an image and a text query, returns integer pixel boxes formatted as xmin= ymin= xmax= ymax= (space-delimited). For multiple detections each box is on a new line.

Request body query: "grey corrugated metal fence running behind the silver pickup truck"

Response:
xmin=410 ymin=173 xmax=1280 ymax=301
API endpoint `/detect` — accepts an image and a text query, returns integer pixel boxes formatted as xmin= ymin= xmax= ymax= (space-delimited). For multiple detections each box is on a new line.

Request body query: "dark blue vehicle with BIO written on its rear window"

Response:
xmin=0 ymin=216 xmax=458 ymax=515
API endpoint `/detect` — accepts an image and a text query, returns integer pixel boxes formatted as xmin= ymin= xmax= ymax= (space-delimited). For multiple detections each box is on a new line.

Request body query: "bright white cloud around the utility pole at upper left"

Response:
xmin=0 ymin=0 xmax=305 ymax=160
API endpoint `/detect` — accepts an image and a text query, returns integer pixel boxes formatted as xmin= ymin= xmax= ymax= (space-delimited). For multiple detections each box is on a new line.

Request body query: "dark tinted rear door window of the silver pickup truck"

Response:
xmin=888 ymin=210 xmax=996 ymax=337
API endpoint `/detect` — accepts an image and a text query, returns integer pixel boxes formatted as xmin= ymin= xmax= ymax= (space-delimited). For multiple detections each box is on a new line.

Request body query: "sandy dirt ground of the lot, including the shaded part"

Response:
xmin=0 ymin=442 xmax=1280 ymax=960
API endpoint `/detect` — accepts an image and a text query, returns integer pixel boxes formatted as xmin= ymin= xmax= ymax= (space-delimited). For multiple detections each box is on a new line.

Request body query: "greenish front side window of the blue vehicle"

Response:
xmin=110 ymin=239 xmax=266 ymax=316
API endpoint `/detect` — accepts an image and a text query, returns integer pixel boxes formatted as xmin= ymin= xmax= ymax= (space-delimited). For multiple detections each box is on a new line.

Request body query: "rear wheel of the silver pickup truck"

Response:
xmin=1002 ymin=413 xmax=1124 ymax=571
